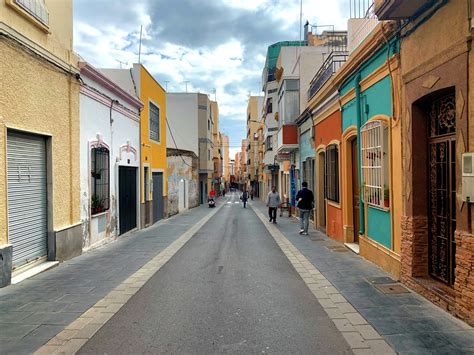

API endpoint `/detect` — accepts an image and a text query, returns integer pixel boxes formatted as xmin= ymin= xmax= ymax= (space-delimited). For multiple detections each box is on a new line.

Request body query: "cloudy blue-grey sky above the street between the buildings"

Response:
xmin=74 ymin=0 xmax=349 ymax=156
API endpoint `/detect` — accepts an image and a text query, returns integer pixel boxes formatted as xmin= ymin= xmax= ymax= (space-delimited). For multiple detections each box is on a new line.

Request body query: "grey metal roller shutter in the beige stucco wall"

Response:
xmin=7 ymin=132 xmax=48 ymax=267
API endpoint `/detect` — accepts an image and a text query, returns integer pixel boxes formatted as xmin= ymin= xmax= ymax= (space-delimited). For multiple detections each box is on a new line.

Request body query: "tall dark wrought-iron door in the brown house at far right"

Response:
xmin=428 ymin=93 xmax=456 ymax=285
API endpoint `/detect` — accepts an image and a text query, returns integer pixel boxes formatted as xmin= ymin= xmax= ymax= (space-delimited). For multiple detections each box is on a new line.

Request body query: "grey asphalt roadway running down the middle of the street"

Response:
xmin=80 ymin=194 xmax=351 ymax=354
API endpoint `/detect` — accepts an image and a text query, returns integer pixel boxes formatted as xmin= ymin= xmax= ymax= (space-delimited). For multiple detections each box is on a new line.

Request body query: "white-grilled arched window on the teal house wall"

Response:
xmin=360 ymin=120 xmax=389 ymax=208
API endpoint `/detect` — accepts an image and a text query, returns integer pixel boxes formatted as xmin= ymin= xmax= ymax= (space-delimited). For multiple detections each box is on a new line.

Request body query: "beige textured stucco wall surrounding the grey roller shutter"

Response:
xmin=0 ymin=39 xmax=80 ymax=244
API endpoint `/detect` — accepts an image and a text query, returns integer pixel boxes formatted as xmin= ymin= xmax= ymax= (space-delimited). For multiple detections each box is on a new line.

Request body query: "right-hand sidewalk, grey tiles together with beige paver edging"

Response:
xmin=251 ymin=201 xmax=474 ymax=354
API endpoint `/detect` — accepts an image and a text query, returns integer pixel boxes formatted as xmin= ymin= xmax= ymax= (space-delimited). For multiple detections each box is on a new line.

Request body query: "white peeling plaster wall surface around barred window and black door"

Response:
xmin=80 ymin=77 xmax=140 ymax=248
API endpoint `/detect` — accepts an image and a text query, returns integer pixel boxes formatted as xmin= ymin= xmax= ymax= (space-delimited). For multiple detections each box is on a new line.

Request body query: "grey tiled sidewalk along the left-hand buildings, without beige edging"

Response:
xmin=0 ymin=205 xmax=217 ymax=354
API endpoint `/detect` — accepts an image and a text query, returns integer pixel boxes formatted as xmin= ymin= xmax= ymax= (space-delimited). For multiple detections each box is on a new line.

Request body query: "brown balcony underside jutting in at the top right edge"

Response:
xmin=375 ymin=0 xmax=433 ymax=20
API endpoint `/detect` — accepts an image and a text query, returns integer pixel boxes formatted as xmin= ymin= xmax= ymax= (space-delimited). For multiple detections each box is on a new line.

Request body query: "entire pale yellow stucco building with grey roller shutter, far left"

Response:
xmin=0 ymin=0 xmax=82 ymax=287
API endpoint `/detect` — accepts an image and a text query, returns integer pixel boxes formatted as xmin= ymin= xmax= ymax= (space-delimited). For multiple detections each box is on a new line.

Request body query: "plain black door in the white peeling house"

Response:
xmin=119 ymin=166 xmax=137 ymax=234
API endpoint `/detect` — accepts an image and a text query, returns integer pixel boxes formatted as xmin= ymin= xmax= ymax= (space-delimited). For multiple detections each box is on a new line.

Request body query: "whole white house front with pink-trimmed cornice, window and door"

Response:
xmin=80 ymin=63 xmax=143 ymax=249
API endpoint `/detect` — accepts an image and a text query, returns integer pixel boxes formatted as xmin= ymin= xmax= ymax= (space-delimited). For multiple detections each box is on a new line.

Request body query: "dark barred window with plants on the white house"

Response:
xmin=91 ymin=147 xmax=110 ymax=214
